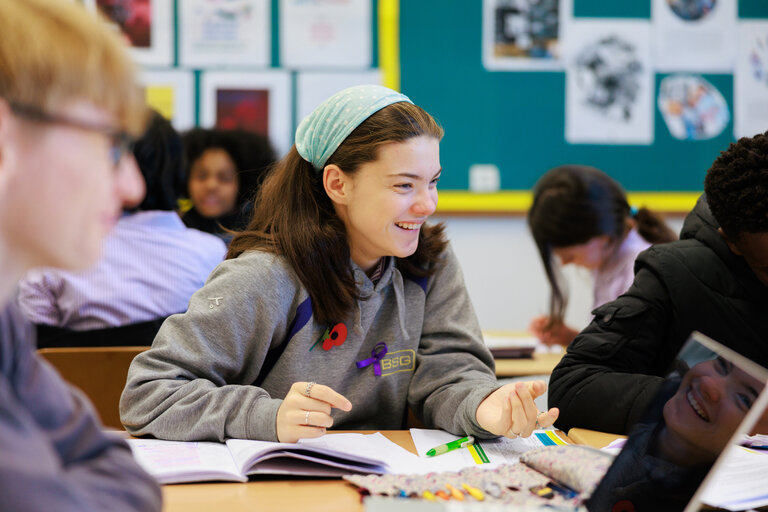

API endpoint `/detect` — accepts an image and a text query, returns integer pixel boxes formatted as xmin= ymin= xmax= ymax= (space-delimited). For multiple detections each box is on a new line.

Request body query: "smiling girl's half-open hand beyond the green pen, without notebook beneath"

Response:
xmin=475 ymin=380 xmax=560 ymax=439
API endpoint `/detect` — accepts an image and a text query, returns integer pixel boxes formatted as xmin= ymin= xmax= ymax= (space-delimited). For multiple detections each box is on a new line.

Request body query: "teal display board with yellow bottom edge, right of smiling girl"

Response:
xmin=399 ymin=0 xmax=768 ymax=209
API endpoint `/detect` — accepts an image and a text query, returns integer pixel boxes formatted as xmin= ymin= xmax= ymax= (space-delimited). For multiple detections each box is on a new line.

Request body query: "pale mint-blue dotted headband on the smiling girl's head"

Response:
xmin=296 ymin=85 xmax=413 ymax=171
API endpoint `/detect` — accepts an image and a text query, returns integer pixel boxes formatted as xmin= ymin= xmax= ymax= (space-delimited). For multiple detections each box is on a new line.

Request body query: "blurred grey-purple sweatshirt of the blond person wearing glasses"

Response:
xmin=0 ymin=304 xmax=161 ymax=512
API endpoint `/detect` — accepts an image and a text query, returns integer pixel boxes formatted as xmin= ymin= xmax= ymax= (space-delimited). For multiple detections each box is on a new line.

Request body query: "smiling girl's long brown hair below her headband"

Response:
xmin=227 ymin=102 xmax=447 ymax=325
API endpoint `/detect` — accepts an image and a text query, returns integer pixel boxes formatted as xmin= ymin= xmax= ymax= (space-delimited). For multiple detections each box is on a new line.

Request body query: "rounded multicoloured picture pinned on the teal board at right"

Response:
xmin=657 ymin=74 xmax=731 ymax=140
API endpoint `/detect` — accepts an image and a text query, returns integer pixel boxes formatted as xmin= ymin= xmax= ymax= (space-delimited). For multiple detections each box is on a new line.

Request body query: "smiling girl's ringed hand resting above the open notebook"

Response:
xmin=277 ymin=382 xmax=352 ymax=443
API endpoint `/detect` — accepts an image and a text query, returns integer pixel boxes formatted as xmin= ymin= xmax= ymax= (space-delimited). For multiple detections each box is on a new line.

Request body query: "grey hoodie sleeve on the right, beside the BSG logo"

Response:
xmin=408 ymin=246 xmax=499 ymax=437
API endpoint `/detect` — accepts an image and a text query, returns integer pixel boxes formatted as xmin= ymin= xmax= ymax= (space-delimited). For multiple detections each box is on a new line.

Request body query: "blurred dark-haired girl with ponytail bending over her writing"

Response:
xmin=528 ymin=165 xmax=677 ymax=345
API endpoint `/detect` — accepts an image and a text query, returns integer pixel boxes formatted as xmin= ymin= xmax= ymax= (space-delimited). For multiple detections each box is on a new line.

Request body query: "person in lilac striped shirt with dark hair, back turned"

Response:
xmin=19 ymin=112 xmax=227 ymax=347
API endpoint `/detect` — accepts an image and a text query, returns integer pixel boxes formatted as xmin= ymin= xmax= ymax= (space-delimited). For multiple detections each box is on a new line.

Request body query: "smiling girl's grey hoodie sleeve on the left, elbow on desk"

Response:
xmin=120 ymin=253 xmax=297 ymax=441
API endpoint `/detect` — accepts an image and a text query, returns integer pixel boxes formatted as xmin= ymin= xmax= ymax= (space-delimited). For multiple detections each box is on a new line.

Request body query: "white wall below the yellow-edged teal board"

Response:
xmin=433 ymin=215 xmax=684 ymax=331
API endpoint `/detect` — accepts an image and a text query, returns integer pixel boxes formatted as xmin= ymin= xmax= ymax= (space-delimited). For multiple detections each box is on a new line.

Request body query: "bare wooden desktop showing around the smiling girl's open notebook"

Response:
xmin=163 ymin=430 xmax=416 ymax=512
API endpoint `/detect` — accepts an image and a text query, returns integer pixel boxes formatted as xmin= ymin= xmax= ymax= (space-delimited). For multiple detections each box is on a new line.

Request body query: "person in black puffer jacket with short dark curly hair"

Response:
xmin=549 ymin=130 xmax=768 ymax=433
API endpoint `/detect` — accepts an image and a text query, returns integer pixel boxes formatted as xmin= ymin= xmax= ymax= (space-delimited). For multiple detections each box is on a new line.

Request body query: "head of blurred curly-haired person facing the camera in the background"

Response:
xmin=182 ymin=128 xmax=276 ymax=241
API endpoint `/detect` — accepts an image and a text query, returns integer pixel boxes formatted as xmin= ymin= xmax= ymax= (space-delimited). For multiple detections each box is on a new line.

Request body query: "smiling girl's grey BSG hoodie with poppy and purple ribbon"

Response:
xmin=120 ymin=243 xmax=498 ymax=441
